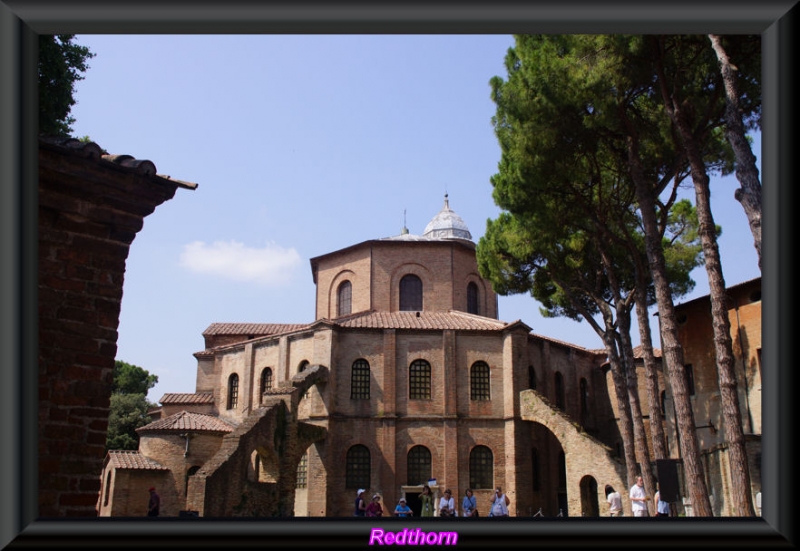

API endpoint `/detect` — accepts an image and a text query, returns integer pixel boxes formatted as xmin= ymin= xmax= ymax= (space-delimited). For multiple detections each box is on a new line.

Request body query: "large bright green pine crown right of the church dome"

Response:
xmin=477 ymin=35 xmax=708 ymax=332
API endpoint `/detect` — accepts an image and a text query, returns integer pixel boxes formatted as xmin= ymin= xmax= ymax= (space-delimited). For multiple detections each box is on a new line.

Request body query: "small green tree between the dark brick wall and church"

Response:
xmin=106 ymin=360 xmax=158 ymax=450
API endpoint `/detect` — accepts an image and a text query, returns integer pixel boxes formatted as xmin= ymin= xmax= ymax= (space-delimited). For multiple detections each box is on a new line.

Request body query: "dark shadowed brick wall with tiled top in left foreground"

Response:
xmin=38 ymin=140 xmax=194 ymax=516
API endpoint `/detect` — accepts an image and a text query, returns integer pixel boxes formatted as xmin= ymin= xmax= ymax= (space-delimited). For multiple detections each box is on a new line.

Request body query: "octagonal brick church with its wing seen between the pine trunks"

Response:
xmin=97 ymin=196 xmax=760 ymax=517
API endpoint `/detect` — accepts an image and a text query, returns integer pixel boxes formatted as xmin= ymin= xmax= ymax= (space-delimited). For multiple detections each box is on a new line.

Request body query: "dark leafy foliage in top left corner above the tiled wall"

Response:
xmin=39 ymin=34 xmax=95 ymax=137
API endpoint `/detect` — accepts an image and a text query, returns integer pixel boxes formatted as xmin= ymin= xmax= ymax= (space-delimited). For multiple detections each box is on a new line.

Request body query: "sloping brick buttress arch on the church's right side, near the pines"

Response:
xmin=520 ymin=390 xmax=632 ymax=515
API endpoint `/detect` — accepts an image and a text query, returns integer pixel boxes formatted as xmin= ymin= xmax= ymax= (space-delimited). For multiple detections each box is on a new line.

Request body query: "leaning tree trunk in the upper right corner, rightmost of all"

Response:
xmin=708 ymin=34 xmax=761 ymax=270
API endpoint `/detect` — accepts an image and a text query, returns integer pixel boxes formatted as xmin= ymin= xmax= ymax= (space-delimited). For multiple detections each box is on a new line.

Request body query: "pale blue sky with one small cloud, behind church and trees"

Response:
xmin=65 ymin=35 xmax=760 ymax=401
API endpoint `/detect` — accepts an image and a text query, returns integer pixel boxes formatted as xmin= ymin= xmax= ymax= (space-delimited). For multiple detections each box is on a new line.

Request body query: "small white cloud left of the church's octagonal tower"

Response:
xmin=180 ymin=241 xmax=300 ymax=285
